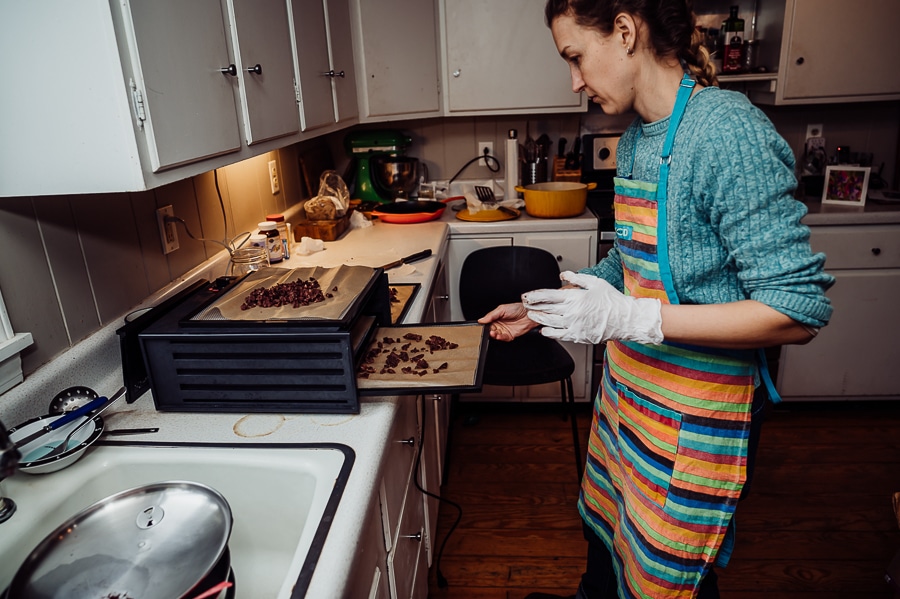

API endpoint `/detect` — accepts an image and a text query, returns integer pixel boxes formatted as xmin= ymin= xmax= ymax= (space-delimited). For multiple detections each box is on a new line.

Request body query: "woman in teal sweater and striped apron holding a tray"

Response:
xmin=480 ymin=0 xmax=833 ymax=599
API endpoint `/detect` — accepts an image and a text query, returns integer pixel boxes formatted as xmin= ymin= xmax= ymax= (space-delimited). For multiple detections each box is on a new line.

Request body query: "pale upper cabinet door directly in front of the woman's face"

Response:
xmin=440 ymin=0 xmax=587 ymax=115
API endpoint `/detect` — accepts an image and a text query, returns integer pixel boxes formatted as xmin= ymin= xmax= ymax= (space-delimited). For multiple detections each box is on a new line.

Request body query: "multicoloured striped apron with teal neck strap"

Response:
xmin=578 ymin=75 xmax=758 ymax=599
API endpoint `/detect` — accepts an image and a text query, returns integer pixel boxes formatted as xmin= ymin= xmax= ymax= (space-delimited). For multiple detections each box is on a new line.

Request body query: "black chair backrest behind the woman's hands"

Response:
xmin=459 ymin=245 xmax=560 ymax=320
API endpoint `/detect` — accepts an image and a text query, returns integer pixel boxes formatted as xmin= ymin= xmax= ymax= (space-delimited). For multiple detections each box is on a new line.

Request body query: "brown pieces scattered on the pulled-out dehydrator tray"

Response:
xmin=357 ymin=333 xmax=459 ymax=379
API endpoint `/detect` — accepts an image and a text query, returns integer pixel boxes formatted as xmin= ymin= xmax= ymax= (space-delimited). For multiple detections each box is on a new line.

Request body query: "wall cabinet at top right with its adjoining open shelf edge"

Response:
xmin=695 ymin=0 xmax=900 ymax=105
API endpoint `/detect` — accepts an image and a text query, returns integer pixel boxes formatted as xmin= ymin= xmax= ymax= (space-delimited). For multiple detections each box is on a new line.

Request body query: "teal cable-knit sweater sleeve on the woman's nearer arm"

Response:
xmin=701 ymin=103 xmax=834 ymax=326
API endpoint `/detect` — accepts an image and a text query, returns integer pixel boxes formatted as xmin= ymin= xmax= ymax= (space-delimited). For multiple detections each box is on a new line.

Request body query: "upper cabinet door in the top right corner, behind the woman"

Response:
xmin=781 ymin=0 xmax=900 ymax=102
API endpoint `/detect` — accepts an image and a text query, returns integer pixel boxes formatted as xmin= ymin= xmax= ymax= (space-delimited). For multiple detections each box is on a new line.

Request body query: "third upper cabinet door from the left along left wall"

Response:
xmin=288 ymin=0 xmax=336 ymax=131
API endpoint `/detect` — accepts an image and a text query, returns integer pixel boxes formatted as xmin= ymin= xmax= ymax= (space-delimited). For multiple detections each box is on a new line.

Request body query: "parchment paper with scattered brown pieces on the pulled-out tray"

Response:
xmin=356 ymin=324 xmax=485 ymax=389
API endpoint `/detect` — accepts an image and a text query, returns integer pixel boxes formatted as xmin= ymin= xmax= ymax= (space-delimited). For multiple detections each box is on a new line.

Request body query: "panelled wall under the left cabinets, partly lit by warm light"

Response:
xmin=0 ymin=147 xmax=303 ymax=376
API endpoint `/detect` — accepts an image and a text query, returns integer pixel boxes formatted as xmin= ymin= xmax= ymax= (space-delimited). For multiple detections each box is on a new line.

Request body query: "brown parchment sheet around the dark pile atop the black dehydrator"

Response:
xmin=191 ymin=265 xmax=375 ymax=320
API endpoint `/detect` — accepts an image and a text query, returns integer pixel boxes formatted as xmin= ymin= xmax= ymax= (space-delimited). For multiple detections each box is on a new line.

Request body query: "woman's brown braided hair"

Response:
xmin=544 ymin=0 xmax=719 ymax=86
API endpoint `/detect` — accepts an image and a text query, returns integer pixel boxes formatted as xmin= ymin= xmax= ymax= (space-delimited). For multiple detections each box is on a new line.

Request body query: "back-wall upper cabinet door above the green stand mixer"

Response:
xmin=350 ymin=0 xmax=441 ymax=122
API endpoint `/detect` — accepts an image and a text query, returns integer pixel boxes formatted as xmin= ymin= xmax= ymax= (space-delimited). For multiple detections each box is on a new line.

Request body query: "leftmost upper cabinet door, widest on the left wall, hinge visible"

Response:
xmin=124 ymin=0 xmax=241 ymax=171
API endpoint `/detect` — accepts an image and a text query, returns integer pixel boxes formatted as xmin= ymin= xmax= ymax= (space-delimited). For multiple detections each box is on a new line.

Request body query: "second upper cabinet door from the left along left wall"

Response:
xmin=229 ymin=0 xmax=300 ymax=144
